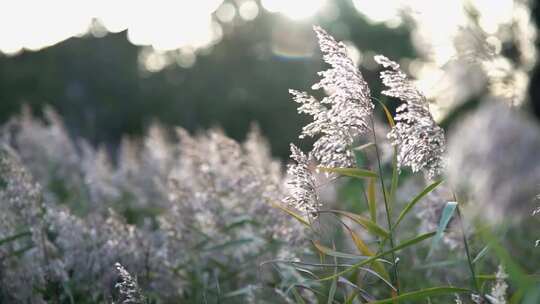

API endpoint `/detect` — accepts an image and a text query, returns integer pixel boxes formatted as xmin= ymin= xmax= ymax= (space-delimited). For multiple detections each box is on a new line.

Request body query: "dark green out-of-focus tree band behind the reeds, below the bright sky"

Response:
xmin=0 ymin=0 xmax=540 ymax=158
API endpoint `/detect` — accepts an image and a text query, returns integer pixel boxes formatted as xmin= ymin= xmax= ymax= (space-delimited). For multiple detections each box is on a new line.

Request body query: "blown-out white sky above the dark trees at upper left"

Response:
xmin=0 ymin=0 xmax=223 ymax=54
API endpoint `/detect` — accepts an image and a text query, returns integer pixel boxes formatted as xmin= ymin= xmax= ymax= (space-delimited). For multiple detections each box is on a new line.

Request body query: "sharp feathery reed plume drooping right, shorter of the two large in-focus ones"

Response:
xmin=375 ymin=55 xmax=445 ymax=179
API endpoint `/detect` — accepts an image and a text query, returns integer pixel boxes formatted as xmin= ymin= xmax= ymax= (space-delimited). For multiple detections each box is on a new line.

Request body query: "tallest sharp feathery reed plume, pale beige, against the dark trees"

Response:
xmin=290 ymin=26 xmax=374 ymax=167
